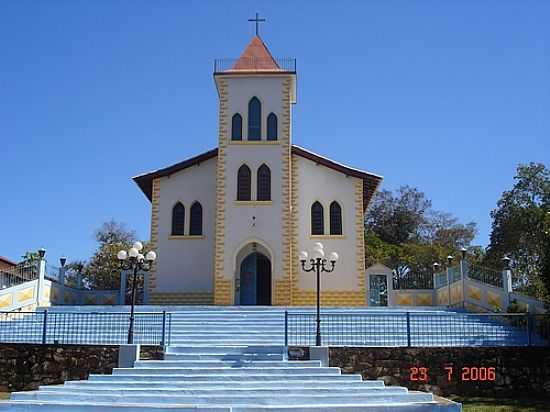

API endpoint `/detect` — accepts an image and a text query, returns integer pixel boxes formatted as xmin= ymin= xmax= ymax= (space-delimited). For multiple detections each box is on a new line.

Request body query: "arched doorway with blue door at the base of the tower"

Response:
xmin=239 ymin=252 xmax=271 ymax=305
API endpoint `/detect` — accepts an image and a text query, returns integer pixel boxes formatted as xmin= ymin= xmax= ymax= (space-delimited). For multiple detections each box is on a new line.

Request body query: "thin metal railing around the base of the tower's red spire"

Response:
xmin=214 ymin=56 xmax=296 ymax=74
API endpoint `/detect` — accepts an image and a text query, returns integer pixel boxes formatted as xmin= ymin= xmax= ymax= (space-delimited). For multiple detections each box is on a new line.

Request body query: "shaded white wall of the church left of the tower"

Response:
xmin=154 ymin=158 xmax=217 ymax=293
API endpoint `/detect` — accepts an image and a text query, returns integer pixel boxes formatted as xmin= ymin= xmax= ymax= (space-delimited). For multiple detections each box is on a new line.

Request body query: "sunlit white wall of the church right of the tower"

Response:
xmin=293 ymin=155 xmax=364 ymax=290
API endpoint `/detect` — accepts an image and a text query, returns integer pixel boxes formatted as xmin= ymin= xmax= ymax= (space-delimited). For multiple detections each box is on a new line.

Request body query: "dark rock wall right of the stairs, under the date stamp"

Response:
xmin=289 ymin=347 xmax=550 ymax=397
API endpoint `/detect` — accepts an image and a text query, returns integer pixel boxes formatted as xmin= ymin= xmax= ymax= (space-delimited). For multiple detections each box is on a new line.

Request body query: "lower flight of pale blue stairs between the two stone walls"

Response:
xmin=0 ymin=345 xmax=461 ymax=412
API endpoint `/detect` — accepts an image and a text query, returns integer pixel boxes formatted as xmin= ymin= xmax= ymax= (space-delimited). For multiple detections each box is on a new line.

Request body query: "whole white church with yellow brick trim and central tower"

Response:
xmin=134 ymin=35 xmax=382 ymax=306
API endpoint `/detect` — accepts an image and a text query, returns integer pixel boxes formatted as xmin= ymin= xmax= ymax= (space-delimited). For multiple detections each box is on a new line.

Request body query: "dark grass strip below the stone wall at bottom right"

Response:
xmin=451 ymin=397 xmax=550 ymax=412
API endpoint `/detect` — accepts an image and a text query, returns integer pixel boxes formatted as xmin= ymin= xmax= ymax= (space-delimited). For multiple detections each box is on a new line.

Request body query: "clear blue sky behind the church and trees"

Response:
xmin=0 ymin=0 xmax=550 ymax=260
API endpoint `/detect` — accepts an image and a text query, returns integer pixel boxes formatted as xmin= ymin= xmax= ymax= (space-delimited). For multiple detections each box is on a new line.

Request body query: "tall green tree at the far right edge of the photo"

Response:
xmin=486 ymin=163 xmax=550 ymax=301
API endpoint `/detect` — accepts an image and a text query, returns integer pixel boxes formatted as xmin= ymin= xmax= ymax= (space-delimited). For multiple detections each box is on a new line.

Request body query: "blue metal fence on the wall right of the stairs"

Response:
xmin=285 ymin=312 xmax=550 ymax=347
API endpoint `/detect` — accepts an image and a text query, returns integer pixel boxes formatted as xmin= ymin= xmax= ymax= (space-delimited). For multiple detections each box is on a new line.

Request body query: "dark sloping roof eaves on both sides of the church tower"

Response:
xmin=133 ymin=145 xmax=383 ymax=209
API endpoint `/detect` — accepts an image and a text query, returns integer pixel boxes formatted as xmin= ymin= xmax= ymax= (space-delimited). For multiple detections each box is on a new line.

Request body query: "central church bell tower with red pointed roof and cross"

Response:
xmin=214 ymin=29 xmax=296 ymax=305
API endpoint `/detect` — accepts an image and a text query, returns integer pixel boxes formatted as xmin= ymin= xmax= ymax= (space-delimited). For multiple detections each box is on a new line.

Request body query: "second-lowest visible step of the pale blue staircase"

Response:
xmin=11 ymin=391 xmax=433 ymax=408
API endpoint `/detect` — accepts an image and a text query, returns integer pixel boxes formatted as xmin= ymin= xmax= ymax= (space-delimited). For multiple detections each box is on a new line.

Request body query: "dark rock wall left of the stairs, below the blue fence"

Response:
xmin=0 ymin=343 xmax=164 ymax=392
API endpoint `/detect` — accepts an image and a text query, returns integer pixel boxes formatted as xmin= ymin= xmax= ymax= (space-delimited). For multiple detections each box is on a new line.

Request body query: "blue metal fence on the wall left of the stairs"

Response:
xmin=0 ymin=310 xmax=172 ymax=345
